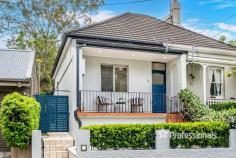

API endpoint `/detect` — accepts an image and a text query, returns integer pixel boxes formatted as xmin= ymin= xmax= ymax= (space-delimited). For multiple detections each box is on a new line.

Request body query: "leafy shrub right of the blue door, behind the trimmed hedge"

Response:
xmin=178 ymin=89 xmax=235 ymax=126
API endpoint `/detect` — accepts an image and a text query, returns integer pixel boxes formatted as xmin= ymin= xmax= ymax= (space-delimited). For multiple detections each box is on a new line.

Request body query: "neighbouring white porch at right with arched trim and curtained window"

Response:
xmin=186 ymin=62 xmax=236 ymax=106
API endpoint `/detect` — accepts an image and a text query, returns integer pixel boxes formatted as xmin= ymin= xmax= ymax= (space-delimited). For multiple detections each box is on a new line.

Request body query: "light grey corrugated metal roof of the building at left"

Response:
xmin=0 ymin=49 xmax=35 ymax=81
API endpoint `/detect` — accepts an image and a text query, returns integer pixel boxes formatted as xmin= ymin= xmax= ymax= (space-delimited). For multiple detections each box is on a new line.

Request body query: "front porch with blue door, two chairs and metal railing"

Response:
xmin=78 ymin=47 xmax=186 ymax=117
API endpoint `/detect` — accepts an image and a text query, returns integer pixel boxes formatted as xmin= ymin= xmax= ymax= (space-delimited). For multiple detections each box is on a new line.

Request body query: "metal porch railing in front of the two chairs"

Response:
xmin=79 ymin=90 xmax=166 ymax=113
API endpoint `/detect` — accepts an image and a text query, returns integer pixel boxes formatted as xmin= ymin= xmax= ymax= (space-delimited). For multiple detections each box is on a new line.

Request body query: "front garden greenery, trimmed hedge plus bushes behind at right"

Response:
xmin=82 ymin=89 xmax=236 ymax=150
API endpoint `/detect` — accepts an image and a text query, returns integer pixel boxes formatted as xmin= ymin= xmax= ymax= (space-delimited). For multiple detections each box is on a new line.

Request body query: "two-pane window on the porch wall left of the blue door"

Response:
xmin=101 ymin=65 xmax=128 ymax=92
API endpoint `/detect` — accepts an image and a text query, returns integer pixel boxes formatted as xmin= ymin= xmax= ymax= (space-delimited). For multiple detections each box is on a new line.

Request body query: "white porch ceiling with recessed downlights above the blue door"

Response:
xmin=83 ymin=47 xmax=178 ymax=63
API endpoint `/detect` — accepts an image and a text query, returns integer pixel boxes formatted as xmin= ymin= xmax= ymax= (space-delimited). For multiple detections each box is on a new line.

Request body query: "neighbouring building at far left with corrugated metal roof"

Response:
xmin=0 ymin=49 xmax=38 ymax=151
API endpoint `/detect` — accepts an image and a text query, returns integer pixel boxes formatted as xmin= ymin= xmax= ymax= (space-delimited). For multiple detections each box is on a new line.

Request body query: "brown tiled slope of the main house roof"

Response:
xmin=70 ymin=13 xmax=236 ymax=50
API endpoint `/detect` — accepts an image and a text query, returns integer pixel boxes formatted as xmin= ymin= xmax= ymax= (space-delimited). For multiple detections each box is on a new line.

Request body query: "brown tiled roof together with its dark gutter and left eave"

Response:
xmin=52 ymin=13 xmax=236 ymax=76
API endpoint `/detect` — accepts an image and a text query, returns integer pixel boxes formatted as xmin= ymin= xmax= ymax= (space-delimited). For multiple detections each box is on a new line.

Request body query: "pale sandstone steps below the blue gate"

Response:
xmin=42 ymin=132 xmax=74 ymax=158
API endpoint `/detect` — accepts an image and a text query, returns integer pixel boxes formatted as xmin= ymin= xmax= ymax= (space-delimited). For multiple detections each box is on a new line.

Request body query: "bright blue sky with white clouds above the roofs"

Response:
xmin=0 ymin=0 xmax=236 ymax=48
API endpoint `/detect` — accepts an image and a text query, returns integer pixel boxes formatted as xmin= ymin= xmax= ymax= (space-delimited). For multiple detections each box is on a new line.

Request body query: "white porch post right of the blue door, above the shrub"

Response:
xmin=178 ymin=54 xmax=187 ymax=90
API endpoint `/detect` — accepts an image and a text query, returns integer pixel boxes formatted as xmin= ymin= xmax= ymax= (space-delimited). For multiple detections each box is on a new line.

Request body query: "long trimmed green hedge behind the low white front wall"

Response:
xmin=81 ymin=122 xmax=229 ymax=150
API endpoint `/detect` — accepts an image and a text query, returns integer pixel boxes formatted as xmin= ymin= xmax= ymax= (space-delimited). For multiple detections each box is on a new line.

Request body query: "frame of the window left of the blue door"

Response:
xmin=100 ymin=64 xmax=129 ymax=92
